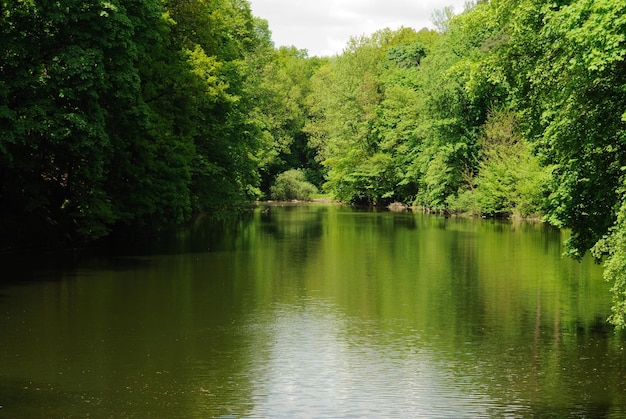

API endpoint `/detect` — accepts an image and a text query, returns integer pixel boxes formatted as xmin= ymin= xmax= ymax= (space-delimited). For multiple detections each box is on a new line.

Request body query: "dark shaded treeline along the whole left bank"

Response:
xmin=0 ymin=0 xmax=320 ymax=244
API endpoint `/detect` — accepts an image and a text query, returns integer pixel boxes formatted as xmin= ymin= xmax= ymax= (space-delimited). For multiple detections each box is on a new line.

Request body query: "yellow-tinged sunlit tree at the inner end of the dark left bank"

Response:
xmin=166 ymin=0 xmax=270 ymax=211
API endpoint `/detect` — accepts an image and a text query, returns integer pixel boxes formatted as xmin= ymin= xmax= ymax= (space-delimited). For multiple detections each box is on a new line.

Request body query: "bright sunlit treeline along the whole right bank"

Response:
xmin=305 ymin=0 xmax=626 ymax=327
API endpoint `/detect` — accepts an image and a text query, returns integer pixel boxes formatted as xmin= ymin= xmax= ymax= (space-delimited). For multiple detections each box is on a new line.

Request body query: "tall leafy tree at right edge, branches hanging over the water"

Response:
xmin=500 ymin=0 xmax=626 ymax=327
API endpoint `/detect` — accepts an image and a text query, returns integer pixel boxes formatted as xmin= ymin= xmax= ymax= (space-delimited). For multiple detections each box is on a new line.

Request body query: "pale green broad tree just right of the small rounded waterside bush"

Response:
xmin=306 ymin=28 xmax=424 ymax=204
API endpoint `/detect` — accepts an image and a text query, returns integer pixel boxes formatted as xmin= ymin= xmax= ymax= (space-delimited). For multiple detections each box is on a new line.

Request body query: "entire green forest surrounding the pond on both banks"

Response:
xmin=0 ymin=0 xmax=626 ymax=327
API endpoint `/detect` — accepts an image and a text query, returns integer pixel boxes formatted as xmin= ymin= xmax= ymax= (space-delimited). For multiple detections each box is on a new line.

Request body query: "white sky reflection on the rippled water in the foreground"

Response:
xmin=246 ymin=300 xmax=508 ymax=418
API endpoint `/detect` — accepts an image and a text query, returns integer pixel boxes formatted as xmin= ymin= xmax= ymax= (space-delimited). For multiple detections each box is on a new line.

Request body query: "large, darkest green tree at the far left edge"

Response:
xmin=0 ymin=1 xmax=173 ymax=237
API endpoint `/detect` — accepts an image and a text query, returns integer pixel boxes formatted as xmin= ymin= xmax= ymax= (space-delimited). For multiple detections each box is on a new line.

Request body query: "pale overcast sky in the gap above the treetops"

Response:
xmin=250 ymin=0 xmax=465 ymax=56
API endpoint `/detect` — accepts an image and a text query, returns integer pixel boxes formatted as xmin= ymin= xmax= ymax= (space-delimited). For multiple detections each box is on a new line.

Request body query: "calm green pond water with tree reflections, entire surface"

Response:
xmin=0 ymin=205 xmax=626 ymax=418
